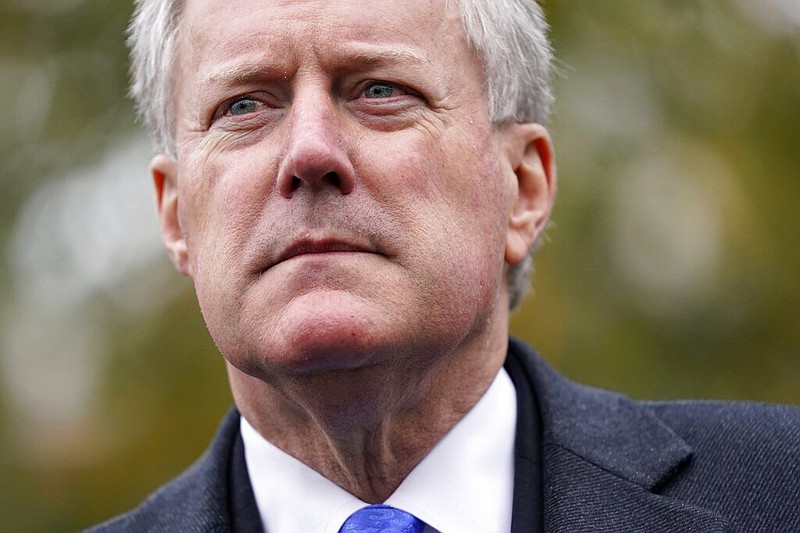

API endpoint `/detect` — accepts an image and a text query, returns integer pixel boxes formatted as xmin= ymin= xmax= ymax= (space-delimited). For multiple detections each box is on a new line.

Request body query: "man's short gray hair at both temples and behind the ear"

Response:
xmin=128 ymin=0 xmax=553 ymax=310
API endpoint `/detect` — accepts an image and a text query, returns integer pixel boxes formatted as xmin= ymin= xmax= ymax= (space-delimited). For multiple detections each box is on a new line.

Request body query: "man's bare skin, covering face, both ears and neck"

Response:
xmin=152 ymin=0 xmax=555 ymax=503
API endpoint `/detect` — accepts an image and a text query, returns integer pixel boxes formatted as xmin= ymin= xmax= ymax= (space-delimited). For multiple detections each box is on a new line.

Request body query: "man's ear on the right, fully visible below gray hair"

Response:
xmin=500 ymin=122 xmax=556 ymax=265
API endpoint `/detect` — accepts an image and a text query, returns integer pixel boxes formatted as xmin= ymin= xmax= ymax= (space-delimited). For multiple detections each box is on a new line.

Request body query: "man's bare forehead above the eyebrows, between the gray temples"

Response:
xmin=180 ymin=0 xmax=468 ymax=73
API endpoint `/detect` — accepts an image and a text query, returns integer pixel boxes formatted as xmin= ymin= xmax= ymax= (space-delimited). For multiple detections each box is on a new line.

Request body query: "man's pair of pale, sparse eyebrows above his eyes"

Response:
xmin=203 ymin=46 xmax=427 ymax=85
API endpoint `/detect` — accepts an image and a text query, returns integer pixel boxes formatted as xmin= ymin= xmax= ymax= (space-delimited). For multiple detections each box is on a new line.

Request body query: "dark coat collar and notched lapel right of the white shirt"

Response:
xmin=506 ymin=340 xmax=727 ymax=533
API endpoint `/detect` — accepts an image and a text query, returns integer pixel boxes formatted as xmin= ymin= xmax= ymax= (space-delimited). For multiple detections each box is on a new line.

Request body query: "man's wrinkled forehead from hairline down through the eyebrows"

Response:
xmin=166 ymin=0 xmax=488 ymax=129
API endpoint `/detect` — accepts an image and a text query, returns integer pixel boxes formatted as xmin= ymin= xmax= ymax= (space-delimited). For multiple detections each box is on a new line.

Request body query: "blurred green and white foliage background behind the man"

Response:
xmin=0 ymin=0 xmax=800 ymax=533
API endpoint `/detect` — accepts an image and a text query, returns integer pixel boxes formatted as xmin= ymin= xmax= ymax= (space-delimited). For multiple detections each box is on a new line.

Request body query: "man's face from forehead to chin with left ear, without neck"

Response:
xmin=154 ymin=0 xmax=552 ymax=376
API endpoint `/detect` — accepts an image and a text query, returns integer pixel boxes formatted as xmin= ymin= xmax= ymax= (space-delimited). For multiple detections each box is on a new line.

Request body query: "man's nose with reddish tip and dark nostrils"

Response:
xmin=278 ymin=93 xmax=355 ymax=199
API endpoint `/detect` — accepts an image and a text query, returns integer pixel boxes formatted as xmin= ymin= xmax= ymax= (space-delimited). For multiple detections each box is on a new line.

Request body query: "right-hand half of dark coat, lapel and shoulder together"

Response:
xmin=507 ymin=339 xmax=800 ymax=533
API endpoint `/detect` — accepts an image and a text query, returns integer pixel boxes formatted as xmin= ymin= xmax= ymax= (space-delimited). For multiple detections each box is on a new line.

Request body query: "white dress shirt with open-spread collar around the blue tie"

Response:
xmin=241 ymin=369 xmax=517 ymax=533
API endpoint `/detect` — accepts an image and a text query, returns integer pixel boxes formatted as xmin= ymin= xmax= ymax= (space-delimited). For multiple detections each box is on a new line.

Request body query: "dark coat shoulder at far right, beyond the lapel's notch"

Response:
xmin=645 ymin=401 xmax=800 ymax=531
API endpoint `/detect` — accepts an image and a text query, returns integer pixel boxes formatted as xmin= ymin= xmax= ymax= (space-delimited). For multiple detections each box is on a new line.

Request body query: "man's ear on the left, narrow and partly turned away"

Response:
xmin=150 ymin=154 xmax=192 ymax=277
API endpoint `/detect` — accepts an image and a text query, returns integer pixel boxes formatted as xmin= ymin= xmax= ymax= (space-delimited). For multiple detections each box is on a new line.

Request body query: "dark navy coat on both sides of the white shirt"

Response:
xmin=87 ymin=340 xmax=800 ymax=533
